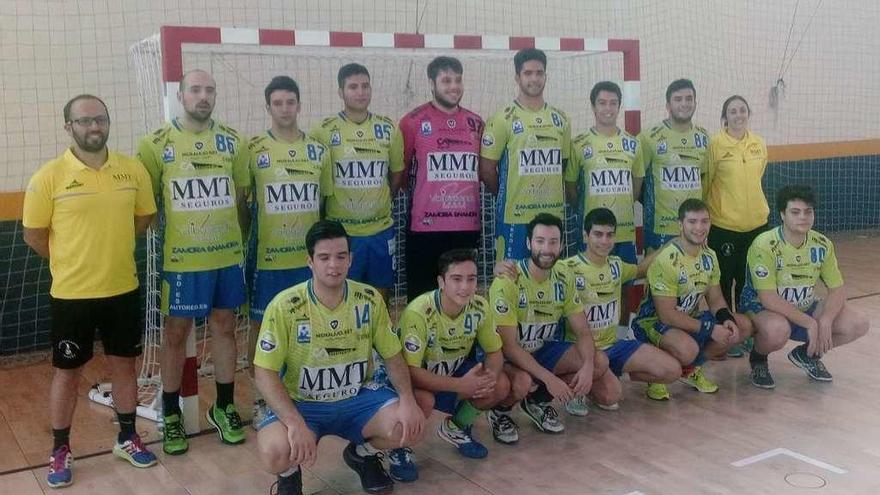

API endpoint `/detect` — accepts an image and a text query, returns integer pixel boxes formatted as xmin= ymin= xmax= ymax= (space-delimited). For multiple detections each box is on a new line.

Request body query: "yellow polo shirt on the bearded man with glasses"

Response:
xmin=22 ymin=149 xmax=156 ymax=299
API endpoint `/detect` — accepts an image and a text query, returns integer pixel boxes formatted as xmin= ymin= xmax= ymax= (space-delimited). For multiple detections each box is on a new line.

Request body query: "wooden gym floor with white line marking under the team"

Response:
xmin=0 ymin=235 xmax=880 ymax=495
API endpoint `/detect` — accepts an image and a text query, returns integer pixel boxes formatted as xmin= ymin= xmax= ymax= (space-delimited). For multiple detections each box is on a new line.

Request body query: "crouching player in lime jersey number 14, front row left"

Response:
xmin=254 ymin=220 xmax=424 ymax=495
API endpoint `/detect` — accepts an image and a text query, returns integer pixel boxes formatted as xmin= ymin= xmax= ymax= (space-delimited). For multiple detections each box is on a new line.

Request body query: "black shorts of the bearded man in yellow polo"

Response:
xmin=49 ymin=289 xmax=143 ymax=369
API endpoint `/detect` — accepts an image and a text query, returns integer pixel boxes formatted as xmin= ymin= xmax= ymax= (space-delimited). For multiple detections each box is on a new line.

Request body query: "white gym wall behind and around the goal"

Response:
xmin=0 ymin=0 xmax=880 ymax=191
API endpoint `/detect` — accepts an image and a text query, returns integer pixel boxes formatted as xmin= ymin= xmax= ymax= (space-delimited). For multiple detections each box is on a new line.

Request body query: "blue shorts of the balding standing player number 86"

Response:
xmin=162 ymin=265 xmax=247 ymax=318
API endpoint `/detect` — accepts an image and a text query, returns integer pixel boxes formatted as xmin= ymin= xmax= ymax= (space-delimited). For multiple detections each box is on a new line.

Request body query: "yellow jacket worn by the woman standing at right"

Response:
xmin=703 ymin=130 xmax=770 ymax=232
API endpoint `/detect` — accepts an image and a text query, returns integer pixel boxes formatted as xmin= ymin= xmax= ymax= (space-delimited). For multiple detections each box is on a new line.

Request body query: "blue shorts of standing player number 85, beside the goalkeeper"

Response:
xmin=348 ymin=226 xmax=397 ymax=289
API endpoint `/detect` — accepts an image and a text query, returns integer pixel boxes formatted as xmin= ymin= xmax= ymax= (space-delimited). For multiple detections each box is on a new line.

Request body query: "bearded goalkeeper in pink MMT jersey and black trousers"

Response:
xmin=391 ymin=57 xmax=483 ymax=301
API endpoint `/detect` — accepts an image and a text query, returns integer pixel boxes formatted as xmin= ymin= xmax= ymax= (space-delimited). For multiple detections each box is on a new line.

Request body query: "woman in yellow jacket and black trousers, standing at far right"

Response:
xmin=703 ymin=95 xmax=770 ymax=316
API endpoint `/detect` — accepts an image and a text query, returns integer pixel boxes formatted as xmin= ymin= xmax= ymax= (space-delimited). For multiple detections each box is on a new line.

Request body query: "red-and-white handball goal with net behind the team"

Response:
xmin=117 ymin=26 xmax=641 ymax=432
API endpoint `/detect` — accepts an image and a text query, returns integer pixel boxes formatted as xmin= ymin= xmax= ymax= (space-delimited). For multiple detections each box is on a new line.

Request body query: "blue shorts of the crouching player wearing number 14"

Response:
xmin=256 ymin=387 xmax=398 ymax=444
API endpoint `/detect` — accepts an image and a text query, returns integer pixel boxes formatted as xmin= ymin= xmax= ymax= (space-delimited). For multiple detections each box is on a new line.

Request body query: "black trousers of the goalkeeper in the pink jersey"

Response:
xmin=406 ymin=231 xmax=480 ymax=301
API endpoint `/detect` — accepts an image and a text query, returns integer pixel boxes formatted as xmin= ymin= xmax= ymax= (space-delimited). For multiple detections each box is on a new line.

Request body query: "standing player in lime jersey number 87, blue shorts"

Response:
xmin=248 ymin=76 xmax=330 ymax=424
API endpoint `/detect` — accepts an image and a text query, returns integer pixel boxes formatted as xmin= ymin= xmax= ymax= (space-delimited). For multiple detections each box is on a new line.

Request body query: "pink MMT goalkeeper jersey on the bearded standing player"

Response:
xmin=391 ymin=103 xmax=483 ymax=232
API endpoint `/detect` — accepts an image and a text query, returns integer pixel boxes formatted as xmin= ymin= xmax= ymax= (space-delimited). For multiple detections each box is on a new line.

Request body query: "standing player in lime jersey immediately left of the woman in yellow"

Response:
xmin=639 ymin=79 xmax=709 ymax=251
